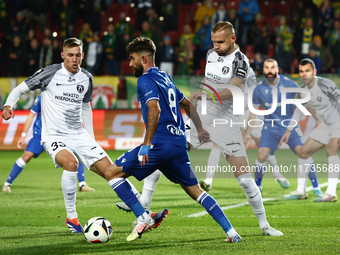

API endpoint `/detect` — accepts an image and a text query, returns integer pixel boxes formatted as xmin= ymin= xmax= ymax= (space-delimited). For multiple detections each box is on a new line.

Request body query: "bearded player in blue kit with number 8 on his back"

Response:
xmin=105 ymin=37 xmax=242 ymax=242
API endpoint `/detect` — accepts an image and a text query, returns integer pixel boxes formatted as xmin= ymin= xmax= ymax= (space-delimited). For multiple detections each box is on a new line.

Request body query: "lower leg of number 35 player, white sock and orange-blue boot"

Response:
xmin=61 ymin=170 xmax=83 ymax=233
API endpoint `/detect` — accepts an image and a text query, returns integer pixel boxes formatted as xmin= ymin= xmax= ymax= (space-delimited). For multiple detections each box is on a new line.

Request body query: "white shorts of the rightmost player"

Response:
xmin=309 ymin=123 xmax=340 ymax=145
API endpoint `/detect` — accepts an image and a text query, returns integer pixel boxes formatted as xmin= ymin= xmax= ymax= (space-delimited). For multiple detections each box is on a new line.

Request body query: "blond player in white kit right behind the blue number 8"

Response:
xmin=189 ymin=21 xmax=283 ymax=236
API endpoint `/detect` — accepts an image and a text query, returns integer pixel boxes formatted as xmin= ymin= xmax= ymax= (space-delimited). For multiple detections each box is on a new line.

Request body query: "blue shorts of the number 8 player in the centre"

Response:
xmin=115 ymin=143 xmax=198 ymax=186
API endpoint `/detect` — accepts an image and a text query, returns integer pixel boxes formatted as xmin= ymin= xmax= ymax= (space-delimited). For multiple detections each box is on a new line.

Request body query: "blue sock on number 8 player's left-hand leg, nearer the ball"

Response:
xmin=108 ymin=178 xmax=145 ymax=218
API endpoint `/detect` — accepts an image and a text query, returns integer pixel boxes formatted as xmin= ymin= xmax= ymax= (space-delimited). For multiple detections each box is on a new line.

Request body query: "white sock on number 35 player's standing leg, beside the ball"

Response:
xmin=61 ymin=170 xmax=78 ymax=219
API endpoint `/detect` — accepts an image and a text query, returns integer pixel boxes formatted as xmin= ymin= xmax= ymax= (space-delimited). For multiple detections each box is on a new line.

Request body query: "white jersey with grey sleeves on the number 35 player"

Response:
xmin=25 ymin=63 xmax=93 ymax=142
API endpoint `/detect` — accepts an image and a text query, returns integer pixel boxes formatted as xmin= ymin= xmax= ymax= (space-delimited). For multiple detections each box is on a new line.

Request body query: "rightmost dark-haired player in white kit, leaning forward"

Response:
xmin=280 ymin=58 xmax=340 ymax=202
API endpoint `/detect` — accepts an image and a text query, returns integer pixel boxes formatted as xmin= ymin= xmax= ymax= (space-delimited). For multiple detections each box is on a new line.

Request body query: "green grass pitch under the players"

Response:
xmin=0 ymin=150 xmax=340 ymax=255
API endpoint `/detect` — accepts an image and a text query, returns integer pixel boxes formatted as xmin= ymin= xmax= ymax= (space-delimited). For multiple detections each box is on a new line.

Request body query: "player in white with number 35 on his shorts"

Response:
xmin=2 ymin=38 xmax=165 ymax=237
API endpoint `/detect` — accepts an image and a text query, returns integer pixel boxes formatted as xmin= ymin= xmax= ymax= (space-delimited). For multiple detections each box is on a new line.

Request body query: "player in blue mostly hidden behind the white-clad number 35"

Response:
xmin=2 ymin=95 xmax=94 ymax=193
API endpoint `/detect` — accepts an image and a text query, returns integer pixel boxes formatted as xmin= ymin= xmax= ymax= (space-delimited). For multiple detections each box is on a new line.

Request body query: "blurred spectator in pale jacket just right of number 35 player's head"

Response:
xmin=86 ymin=32 xmax=103 ymax=75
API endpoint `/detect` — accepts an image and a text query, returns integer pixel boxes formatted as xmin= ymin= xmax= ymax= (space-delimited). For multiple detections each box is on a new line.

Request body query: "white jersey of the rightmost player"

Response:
xmin=303 ymin=76 xmax=340 ymax=125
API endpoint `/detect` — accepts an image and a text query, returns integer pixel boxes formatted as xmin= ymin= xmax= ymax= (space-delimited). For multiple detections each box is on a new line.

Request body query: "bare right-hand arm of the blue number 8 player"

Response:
xmin=179 ymin=98 xmax=210 ymax=142
